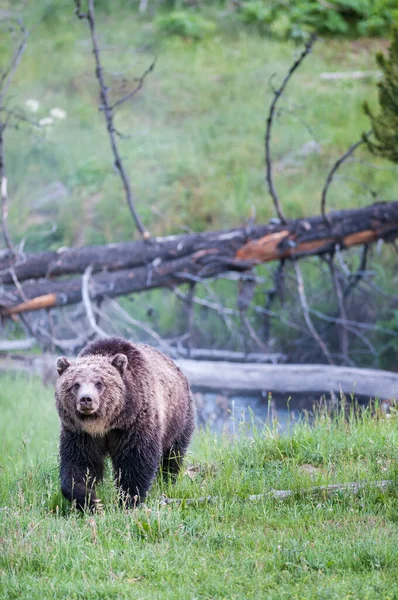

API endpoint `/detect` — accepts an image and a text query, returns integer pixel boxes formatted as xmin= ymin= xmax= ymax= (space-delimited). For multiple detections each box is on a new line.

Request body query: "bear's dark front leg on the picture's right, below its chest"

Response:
xmin=110 ymin=433 xmax=162 ymax=508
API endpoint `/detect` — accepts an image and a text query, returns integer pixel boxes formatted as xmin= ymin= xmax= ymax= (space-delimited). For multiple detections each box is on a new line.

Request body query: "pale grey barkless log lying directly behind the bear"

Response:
xmin=0 ymin=354 xmax=398 ymax=399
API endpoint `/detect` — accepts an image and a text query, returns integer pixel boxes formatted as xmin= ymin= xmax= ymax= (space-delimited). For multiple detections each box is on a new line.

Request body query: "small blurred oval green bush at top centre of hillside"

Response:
xmin=156 ymin=10 xmax=216 ymax=40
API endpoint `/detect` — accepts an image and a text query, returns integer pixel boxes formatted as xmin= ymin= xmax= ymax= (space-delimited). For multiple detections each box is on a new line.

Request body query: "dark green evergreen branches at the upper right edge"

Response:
xmin=364 ymin=29 xmax=398 ymax=163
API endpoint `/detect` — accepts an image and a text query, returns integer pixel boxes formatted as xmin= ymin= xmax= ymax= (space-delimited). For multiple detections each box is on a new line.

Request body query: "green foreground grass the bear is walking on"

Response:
xmin=0 ymin=376 xmax=398 ymax=600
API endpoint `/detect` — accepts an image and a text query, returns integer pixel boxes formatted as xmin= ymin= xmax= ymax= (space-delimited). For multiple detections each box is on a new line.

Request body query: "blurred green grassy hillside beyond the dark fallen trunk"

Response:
xmin=0 ymin=9 xmax=396 ymax=248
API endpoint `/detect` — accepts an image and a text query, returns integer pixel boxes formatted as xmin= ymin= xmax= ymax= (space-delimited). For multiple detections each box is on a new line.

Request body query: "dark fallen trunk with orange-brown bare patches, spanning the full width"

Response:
xmin=0 ymin=201 xmax=398 ymax=316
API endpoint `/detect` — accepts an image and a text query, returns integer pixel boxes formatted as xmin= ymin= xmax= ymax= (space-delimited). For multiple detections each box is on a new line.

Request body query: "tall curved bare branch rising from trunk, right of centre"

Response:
xmin=265 ymin=34 xmax=316 ymax=223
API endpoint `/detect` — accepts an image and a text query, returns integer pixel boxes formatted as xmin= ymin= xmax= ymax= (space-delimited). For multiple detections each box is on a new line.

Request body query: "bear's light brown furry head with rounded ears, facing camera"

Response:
xmin=55 ymin=354 xmax=128 ymax=435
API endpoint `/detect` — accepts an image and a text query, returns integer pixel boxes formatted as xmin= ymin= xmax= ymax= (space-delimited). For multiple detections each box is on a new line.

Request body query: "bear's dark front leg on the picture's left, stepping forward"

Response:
xmin=60 ymin=429 xmax=104 ymax=510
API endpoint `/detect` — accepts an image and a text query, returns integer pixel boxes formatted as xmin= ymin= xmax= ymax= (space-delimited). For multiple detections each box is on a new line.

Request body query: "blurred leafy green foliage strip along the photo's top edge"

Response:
xmin=10 ymin=0 xmax=398 ymax=40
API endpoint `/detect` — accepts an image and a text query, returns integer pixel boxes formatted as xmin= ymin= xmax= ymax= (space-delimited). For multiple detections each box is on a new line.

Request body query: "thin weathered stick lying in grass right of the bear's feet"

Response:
xmin=161 ymin=479 xmax=395 ymax=506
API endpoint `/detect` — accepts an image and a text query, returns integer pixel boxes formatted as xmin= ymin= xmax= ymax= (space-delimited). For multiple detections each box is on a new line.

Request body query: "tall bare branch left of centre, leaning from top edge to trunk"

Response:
xmin=75 ymin=0 xmax=151 ymax=240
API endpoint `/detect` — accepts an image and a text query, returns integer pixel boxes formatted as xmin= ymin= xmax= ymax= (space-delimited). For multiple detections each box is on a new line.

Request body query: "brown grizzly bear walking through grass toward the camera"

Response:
xmin=55 ymin=337 xmax=195 ymax=510
